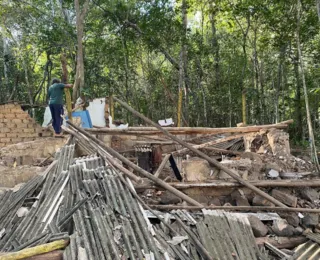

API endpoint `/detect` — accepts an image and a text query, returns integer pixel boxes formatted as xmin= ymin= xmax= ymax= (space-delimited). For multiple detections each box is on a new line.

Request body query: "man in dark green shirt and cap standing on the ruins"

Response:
xmin=48 ymin=79 xmax=73 ymax=137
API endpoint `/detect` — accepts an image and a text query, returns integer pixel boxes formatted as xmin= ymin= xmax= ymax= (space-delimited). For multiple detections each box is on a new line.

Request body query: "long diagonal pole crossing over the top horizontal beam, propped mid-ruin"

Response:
xmin=114 ymin=97 xmax=287 ymax=207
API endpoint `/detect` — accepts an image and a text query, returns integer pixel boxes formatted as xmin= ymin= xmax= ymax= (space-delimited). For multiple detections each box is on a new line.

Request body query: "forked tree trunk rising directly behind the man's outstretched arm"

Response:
xmin=73 ymin=0 xmax=89 ymax=102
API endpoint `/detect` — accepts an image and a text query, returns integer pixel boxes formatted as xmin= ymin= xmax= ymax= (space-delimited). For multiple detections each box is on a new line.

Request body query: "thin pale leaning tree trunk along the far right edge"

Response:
xmin=296 ymin=0 xmax=320 ymax=172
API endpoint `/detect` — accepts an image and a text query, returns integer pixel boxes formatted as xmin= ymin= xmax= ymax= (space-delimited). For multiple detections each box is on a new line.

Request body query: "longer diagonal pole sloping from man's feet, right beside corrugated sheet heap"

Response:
xmin=68 ymin=122 xmax=203 ymax=207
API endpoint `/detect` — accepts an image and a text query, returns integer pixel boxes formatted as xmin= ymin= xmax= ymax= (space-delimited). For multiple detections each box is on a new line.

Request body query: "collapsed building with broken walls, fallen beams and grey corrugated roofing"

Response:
xmin=0 ymin=99 xmax=320 ymax=259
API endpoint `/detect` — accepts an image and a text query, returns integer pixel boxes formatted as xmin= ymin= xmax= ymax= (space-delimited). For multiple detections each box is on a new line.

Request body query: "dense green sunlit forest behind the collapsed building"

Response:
xmin=0 ymin=0 xmax=320 ymax=144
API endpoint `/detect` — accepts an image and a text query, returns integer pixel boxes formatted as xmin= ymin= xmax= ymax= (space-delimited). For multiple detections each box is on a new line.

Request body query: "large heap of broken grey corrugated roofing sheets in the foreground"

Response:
xmin=0 ymin=134 xmax=267 ymax=260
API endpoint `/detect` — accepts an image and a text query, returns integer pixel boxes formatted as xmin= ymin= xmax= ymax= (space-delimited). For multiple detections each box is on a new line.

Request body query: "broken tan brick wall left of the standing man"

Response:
xmin=0 ymin=104 xmax=52 ymax=148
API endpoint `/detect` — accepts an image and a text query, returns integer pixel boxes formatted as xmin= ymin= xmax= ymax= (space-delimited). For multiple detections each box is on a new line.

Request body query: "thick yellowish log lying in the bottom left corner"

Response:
xmin=0 ymin=240 xmax=69 ymax=260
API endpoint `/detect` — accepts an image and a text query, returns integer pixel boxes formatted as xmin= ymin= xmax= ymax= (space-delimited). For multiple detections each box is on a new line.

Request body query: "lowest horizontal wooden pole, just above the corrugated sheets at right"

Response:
xmin=149 ymin=205 xmax=320 ymax=214
